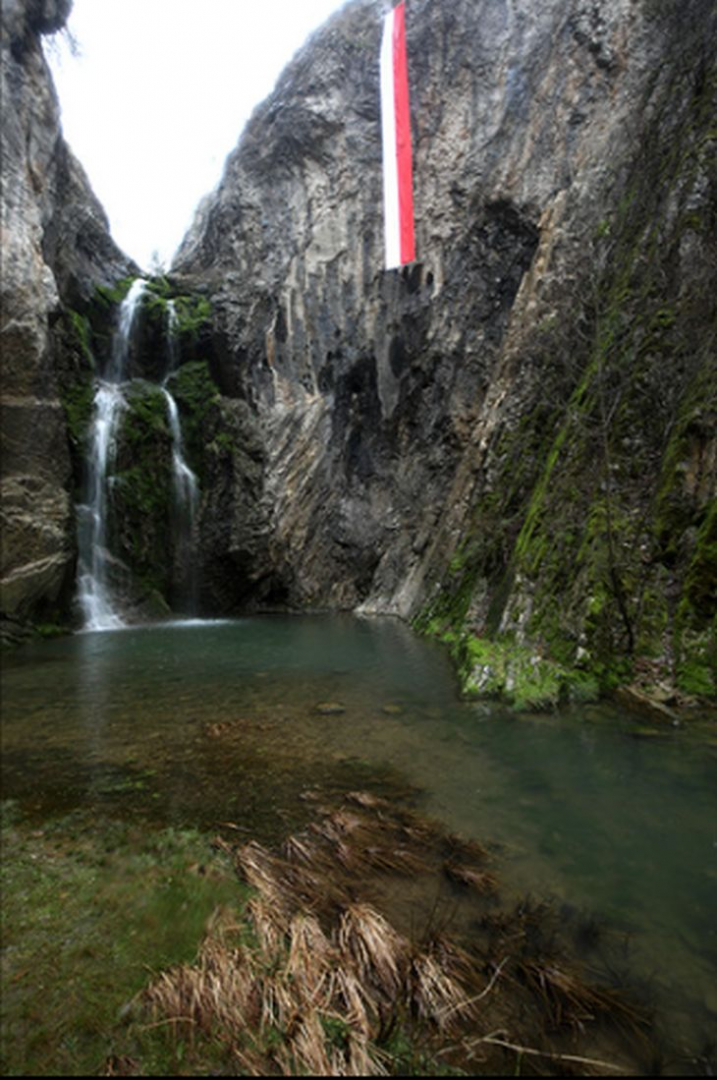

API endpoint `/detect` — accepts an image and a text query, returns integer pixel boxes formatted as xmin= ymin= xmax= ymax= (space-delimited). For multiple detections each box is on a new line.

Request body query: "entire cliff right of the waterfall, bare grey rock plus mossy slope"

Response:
xmin=174 ymin=0 xmax=717 ymax=684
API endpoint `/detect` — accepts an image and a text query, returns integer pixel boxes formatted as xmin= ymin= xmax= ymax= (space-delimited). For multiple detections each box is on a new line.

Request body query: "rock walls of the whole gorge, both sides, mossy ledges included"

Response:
xmin=2 ymin=0 xmax=717 ymax=704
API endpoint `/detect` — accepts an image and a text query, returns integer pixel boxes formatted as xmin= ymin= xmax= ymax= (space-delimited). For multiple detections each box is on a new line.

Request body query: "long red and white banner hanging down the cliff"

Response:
xmin=381 ymin=3 xmax=416 ymax=270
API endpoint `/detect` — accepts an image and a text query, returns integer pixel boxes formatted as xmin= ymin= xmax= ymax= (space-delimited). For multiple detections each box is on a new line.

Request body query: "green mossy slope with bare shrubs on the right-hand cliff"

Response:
xmin=417 ymin=59 xmax=717 ymax=706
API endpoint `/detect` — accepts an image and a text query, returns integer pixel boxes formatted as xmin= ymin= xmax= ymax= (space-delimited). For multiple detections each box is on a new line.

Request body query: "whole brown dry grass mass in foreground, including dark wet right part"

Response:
xmin=143 ymin=792 xmax=638 ymax=1076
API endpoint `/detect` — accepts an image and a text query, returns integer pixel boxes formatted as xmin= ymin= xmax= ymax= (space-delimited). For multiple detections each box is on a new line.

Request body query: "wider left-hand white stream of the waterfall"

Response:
xmin=78 ymin=278 xmax=146 ymax=630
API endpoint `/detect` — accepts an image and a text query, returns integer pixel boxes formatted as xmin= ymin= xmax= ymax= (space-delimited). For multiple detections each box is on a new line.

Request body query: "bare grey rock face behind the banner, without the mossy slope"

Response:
xmin=174 ymin=0 xmax=714 ymax=630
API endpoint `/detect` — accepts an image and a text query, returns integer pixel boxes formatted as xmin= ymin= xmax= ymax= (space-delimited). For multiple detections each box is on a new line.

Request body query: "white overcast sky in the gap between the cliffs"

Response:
xmin=46 ymin=0 xmax=343 ymax=269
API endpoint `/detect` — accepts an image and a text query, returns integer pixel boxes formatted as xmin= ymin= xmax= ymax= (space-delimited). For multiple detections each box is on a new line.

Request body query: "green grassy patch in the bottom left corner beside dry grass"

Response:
xmin=0 ymin=804 xmax=241 ymax=1076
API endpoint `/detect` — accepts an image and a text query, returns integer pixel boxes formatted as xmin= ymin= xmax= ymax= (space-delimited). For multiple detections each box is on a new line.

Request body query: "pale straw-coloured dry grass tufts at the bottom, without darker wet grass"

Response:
xmin=143 ymin=889 xmax=464 ymax=1076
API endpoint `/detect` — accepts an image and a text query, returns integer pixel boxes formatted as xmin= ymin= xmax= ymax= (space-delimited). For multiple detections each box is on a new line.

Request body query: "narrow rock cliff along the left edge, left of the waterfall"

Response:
xmin=0 ymin=0 xmax=131 ymax=635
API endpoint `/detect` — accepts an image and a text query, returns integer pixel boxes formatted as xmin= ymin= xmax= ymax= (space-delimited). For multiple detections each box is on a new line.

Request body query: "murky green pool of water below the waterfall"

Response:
xmin=2 ymin=617 xmax=717 ymax=1067
